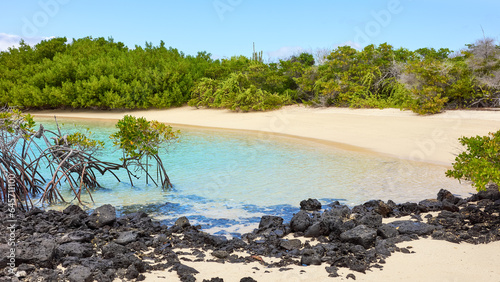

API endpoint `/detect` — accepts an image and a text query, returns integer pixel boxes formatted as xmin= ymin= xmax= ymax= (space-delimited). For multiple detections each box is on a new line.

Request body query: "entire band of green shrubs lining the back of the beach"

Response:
xmin=0 ymin=37 xmax=500 ymax=114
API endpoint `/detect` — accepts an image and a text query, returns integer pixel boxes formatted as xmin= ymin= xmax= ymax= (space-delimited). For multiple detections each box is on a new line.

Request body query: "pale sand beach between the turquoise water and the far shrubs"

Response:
xmin=33 ymin=105 xmax=500 ymax=166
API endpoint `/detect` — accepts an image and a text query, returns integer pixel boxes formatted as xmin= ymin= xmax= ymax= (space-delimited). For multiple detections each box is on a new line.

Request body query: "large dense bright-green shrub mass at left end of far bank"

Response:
xmin=0 ymin=37 xmax=212 ymax=109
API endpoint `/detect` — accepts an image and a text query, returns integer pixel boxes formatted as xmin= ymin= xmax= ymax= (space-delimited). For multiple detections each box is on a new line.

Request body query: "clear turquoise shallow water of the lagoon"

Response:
xmin=37 ymin=115 xmax=473 ymax=235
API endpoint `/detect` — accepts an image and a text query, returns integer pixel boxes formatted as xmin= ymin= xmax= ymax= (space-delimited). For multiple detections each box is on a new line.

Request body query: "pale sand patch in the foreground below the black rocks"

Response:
xmin=139 ymin=239 xmax=500 ymax=282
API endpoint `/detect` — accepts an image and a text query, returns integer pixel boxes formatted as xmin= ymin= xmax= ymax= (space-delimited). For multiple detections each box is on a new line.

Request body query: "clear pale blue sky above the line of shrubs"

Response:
xmin=0 ymin=0 xmax=500 ymax=59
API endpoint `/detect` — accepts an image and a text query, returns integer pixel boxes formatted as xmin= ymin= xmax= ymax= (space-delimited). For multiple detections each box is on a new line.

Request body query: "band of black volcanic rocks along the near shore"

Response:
xmin=0 ymin=185 xmax=500 ymax=281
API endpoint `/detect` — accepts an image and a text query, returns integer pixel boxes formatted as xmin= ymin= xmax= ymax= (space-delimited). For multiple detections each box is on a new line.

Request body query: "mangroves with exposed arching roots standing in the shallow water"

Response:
xmin=0 ymin=108 xmax=178 ymax=209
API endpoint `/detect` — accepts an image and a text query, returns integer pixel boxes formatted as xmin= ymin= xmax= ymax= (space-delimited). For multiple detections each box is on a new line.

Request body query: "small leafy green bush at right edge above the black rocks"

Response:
xmin=446 ymin=130 xmax=500 ymax=191
